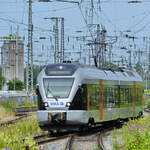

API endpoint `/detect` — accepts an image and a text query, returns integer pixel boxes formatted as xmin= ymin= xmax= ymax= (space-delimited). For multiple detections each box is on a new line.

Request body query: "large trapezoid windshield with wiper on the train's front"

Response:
xmin=44 ymin=78 xmax=74 ymax=98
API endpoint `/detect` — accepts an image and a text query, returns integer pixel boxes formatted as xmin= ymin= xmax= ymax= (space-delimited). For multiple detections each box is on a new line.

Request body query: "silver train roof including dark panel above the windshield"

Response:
xmin=41 ymin=63 xmax=142 ymax=82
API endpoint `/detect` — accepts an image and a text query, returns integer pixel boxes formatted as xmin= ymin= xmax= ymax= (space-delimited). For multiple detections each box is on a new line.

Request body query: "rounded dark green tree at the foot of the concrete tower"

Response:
xmin=7 ymin=78 xmax=24 ymax=91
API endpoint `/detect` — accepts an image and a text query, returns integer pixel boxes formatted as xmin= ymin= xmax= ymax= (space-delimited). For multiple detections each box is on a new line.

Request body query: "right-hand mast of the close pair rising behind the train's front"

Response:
xmin=60 ymin=18 xmax=64 ymax=62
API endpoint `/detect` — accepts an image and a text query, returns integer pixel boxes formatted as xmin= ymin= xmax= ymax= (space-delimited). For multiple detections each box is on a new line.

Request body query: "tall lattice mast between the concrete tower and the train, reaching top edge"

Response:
xmin=26 ymin=0 xmax=33 ymax=92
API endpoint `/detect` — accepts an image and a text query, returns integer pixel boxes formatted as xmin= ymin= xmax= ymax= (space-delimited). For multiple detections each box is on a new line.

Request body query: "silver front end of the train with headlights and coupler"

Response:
xmin=36 ymin=64 xmax=85 ymax=130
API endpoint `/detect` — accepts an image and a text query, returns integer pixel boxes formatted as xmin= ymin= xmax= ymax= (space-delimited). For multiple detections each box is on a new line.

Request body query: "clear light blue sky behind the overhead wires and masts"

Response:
xmin=0 ymin=0 xmax=150 ymax=63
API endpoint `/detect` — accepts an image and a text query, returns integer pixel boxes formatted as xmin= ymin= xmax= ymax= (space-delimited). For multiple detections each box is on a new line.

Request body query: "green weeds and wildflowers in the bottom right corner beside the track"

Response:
xmin=113 ymin=117 xmax=150 ymax=150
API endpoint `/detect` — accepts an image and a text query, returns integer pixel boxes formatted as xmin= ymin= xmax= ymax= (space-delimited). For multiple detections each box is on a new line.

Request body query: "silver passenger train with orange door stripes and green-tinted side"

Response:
xmin=36 ymin=63 xmax=144 ymax=131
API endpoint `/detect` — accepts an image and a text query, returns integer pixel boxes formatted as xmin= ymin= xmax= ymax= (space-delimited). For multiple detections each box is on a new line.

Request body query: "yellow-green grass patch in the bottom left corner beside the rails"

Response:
xmin=0 ymin=116 xmax=43 ymax=150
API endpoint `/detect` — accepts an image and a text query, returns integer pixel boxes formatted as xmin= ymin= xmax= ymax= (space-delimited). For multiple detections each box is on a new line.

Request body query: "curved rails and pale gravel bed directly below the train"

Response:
xmin=36 ymin=123 xmax=122 ymax=150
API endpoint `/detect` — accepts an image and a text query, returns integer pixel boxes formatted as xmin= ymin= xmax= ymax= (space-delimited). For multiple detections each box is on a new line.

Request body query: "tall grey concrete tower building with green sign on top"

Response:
xmin=1 ymin=35 xmax=24 ymax=90
